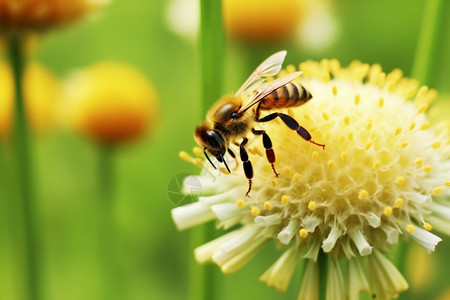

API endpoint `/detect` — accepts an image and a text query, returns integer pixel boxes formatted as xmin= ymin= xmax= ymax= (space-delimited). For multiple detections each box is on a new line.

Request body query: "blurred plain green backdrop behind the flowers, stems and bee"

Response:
xmin=0 ymin=0 xmax=450 ymax=300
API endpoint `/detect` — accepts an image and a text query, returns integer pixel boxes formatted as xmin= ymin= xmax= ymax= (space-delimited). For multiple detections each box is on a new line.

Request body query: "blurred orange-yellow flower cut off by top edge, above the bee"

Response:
xmin=223 ymin=0 xmax=303 ymax=41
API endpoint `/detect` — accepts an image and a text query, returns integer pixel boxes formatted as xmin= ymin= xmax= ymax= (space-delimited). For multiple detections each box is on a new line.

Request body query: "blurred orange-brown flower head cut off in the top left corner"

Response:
xmin=0 ymin=0 xmax=107 ymax=32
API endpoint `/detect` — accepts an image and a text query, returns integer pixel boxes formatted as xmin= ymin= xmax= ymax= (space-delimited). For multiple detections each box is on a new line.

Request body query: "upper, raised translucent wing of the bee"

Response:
xmin=235 ymin=50 xmax=287 ymax=95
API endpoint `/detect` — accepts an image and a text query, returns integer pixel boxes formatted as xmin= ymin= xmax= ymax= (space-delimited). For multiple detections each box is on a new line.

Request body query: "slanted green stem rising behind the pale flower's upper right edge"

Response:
xmin=411 ymin=0 xmax=445 ymax=85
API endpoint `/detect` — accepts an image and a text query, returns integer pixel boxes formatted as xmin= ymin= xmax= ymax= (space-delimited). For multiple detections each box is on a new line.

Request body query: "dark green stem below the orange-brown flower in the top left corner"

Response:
xmin=8 ymin=34 xmax=41 ymax=300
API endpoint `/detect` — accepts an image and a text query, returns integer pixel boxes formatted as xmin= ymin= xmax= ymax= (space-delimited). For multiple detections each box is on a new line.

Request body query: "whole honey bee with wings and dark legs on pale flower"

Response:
xmin=194 ymin=51 xmax=325 ymax=197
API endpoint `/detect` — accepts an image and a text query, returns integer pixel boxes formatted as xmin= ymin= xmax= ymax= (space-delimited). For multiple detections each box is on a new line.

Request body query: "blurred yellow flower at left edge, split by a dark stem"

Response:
xmin=0 ymin=62 xmax=60 ymax=137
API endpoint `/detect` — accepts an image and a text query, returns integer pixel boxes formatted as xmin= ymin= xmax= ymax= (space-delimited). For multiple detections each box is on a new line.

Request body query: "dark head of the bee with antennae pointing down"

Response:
xmin=194 ymin=122 xmax=227 ymax=168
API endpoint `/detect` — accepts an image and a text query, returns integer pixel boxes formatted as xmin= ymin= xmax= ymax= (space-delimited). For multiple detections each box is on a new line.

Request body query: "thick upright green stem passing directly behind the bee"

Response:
xmin=190 ymin=0 xmax=225 ymax=300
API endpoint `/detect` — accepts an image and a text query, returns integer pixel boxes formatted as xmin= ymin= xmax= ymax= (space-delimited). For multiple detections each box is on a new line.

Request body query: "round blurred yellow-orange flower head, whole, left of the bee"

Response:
xmin=62 ymin=62 xmax=157 ymax=144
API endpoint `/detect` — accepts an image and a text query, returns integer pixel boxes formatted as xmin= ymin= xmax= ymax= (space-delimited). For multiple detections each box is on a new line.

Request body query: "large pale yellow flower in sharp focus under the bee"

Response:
xmin=172 ymin=60 xmax=450 ymax=300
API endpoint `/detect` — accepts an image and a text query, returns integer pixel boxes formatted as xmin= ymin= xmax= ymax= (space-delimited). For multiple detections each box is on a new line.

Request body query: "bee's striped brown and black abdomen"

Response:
xmin=260 ymin=82 xmax=312 ymax=110
